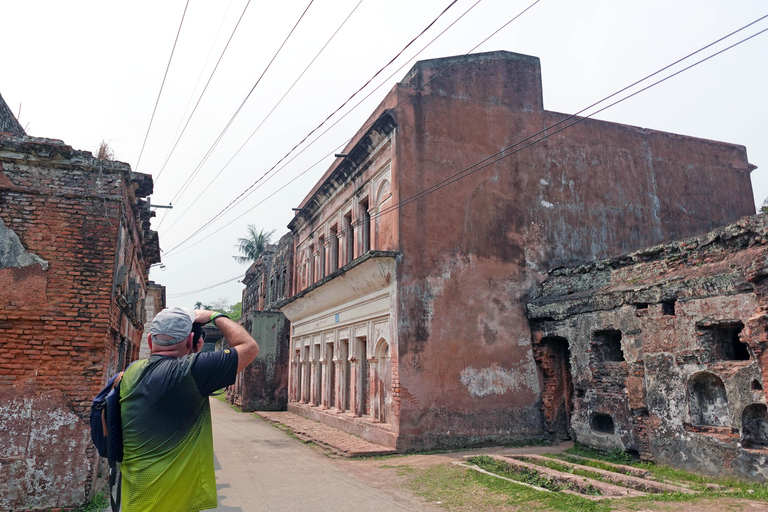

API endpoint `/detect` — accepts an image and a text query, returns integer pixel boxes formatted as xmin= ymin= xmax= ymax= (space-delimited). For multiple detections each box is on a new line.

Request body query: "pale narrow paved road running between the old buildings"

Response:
xmin=211 ymin=399 xmax=425 ymax=512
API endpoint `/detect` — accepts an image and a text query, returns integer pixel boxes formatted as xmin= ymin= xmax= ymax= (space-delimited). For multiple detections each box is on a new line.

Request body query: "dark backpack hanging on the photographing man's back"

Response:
xmin=90 ymin=372 xmax=130 ymax=512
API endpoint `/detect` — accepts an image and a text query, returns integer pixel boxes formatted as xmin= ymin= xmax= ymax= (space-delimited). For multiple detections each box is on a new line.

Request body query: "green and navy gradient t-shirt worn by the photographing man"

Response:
xmin=120 ymin=349 xmax=237 ymax=512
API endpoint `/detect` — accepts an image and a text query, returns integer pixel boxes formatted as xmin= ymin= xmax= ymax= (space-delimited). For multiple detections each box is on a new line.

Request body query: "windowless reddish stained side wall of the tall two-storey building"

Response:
xmin=389 ymin=52 xmax=754 ymax=449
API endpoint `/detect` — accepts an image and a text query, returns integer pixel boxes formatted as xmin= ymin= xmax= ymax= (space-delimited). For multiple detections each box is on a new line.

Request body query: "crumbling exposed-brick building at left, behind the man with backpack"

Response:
xmin=0 ymin=128 xmax=160 ymax=510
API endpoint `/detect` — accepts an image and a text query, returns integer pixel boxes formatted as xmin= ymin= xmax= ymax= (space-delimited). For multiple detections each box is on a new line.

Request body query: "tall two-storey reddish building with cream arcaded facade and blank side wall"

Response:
xmin=277 ymin=52 xmax=754 ymax=450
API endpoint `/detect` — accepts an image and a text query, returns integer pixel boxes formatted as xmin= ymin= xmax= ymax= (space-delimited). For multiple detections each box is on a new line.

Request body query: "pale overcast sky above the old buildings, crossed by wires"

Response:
xmin=0 ymin=0 xmax=768 ymax=305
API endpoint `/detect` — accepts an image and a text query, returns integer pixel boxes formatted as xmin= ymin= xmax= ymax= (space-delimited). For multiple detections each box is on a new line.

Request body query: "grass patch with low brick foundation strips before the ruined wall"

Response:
xmin=390 ymin=445 xmax=768 ymax=512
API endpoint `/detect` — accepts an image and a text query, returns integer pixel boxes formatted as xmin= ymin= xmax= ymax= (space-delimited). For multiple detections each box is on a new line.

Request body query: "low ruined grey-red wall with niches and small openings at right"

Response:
xmin=528 ymin=215 xmax=768 ymax=480
